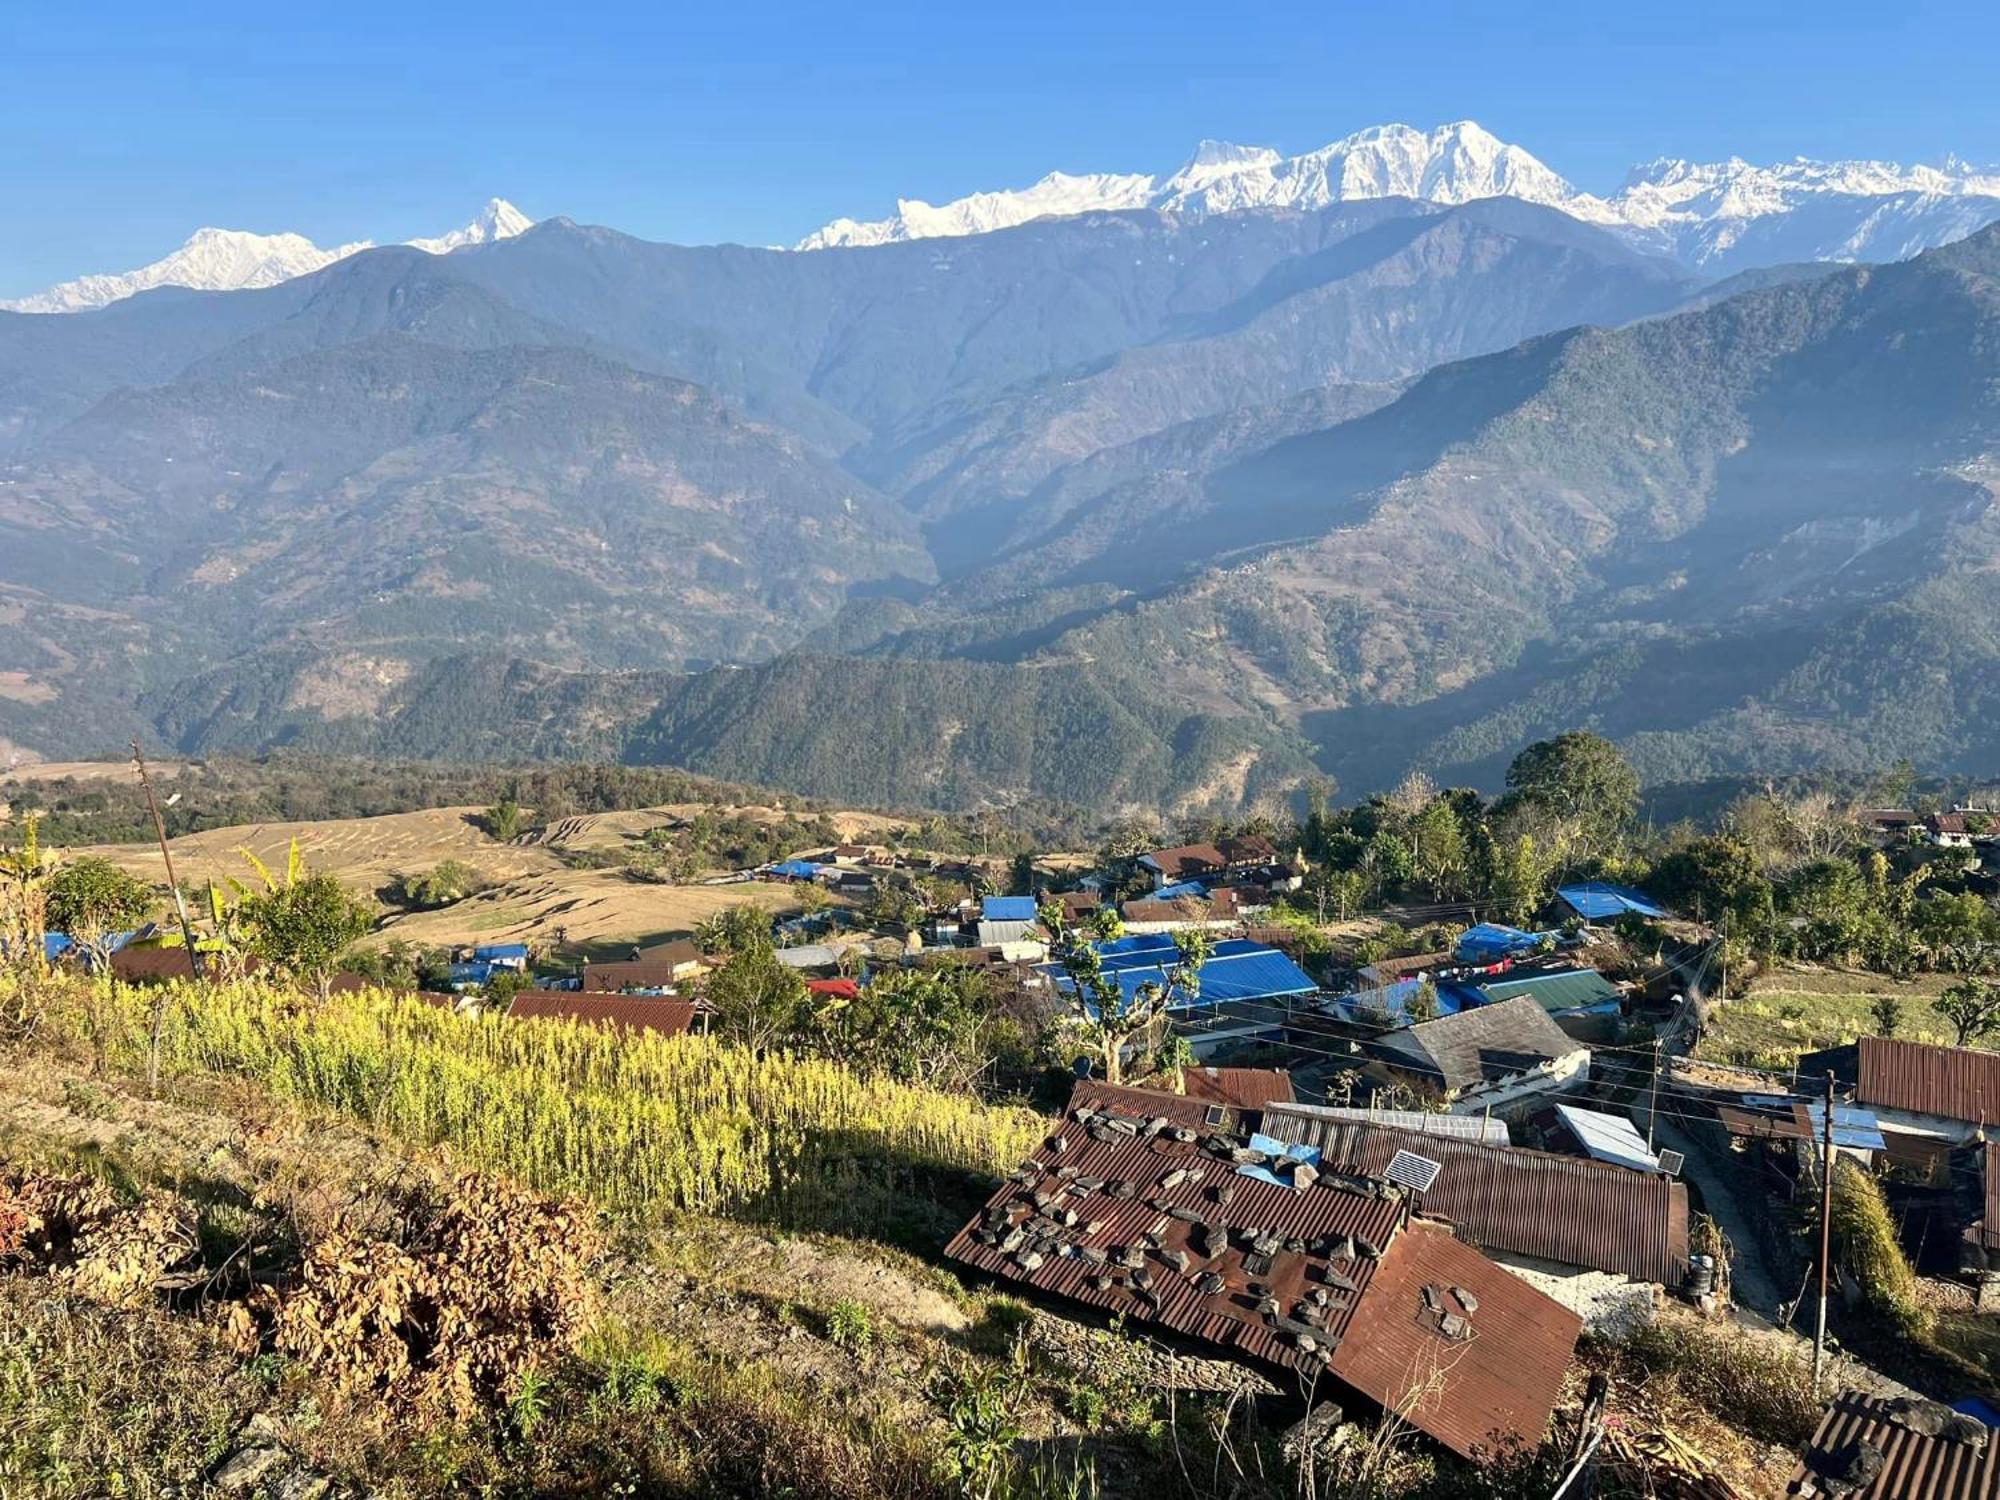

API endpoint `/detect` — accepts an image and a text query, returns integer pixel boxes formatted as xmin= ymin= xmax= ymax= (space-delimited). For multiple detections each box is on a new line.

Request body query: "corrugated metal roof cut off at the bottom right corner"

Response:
xmin=1786 ymin=1390 xmax=2000 ymax=1500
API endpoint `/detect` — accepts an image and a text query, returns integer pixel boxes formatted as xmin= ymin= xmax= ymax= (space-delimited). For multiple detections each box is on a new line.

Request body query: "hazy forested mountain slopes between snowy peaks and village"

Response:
xmin=0 ymin=198 xmax=2000 ymax=812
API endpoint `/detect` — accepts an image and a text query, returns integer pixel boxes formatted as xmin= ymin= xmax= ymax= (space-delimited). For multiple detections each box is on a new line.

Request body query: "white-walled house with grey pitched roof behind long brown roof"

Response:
xmin=1360 ymin=996 xmax=1590 ymax=1114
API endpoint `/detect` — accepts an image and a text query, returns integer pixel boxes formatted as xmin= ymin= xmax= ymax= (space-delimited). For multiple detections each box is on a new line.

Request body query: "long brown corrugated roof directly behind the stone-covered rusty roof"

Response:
xmin=1264 ymin=1108 xmax=1688 ymax=1286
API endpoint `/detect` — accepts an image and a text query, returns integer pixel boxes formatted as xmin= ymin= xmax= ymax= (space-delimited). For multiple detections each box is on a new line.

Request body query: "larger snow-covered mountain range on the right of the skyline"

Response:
xmin=796 ymin=120 xmax=2000 ymax=274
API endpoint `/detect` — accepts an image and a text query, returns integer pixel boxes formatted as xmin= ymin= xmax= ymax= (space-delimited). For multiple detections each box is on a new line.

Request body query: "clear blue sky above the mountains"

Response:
xmin=0 ymin=0 xmax=2000 ymax=296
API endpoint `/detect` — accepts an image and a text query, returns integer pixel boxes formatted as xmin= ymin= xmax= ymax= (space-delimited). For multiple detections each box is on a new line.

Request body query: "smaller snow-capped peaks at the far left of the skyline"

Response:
xmin=0 ymin=198 xmax=534 ymax=312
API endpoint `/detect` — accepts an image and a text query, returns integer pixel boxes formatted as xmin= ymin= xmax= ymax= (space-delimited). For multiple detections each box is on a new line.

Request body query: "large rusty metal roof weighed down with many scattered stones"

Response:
xmin=946 ymin=1084 xmax=1582 ymax=1456
